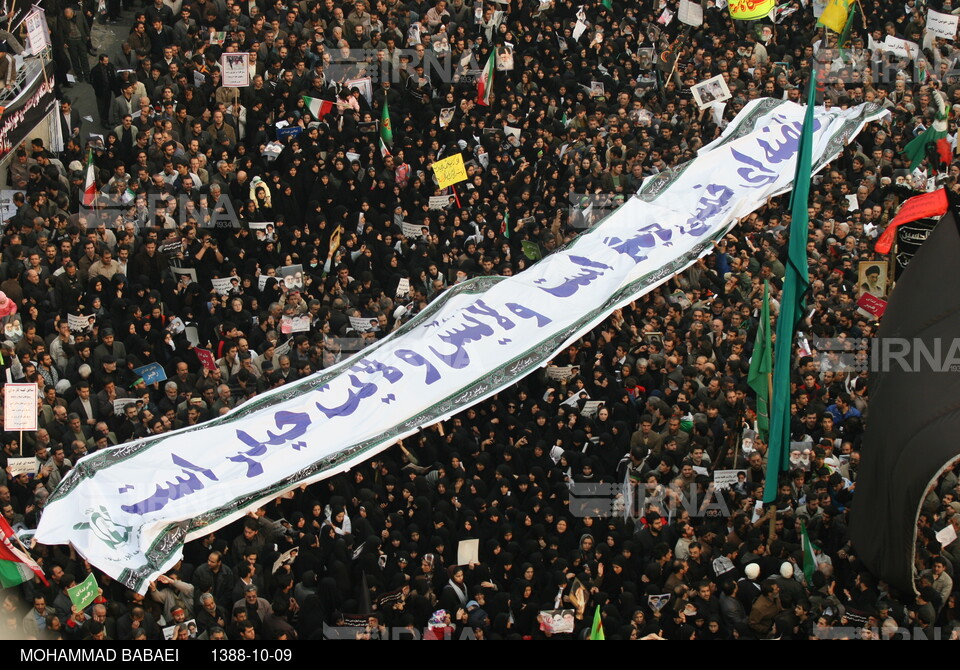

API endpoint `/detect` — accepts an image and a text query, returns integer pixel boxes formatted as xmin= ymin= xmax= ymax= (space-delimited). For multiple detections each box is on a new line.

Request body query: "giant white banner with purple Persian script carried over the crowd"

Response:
xmin=37 ymin=99 xmax=884 ymax=592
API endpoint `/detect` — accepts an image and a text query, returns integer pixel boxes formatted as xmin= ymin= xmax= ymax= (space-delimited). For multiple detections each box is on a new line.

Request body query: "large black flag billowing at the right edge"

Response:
xmin=850 ymin=197 xmax=960 ymax=594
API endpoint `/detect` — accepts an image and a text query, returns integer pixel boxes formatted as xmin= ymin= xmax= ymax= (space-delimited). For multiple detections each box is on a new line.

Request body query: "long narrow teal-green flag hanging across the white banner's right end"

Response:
xmin=763 ymin=70 xmax=817 ymax=503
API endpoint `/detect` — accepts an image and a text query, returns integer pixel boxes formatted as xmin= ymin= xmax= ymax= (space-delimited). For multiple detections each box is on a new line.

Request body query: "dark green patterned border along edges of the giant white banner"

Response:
xmin=48 ymin=100 xmax=883 ymax=590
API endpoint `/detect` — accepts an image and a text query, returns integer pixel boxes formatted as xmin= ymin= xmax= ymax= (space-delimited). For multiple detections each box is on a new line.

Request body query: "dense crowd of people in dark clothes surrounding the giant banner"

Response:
xmin=0 ymin=0 xmax=960 ymax=640
